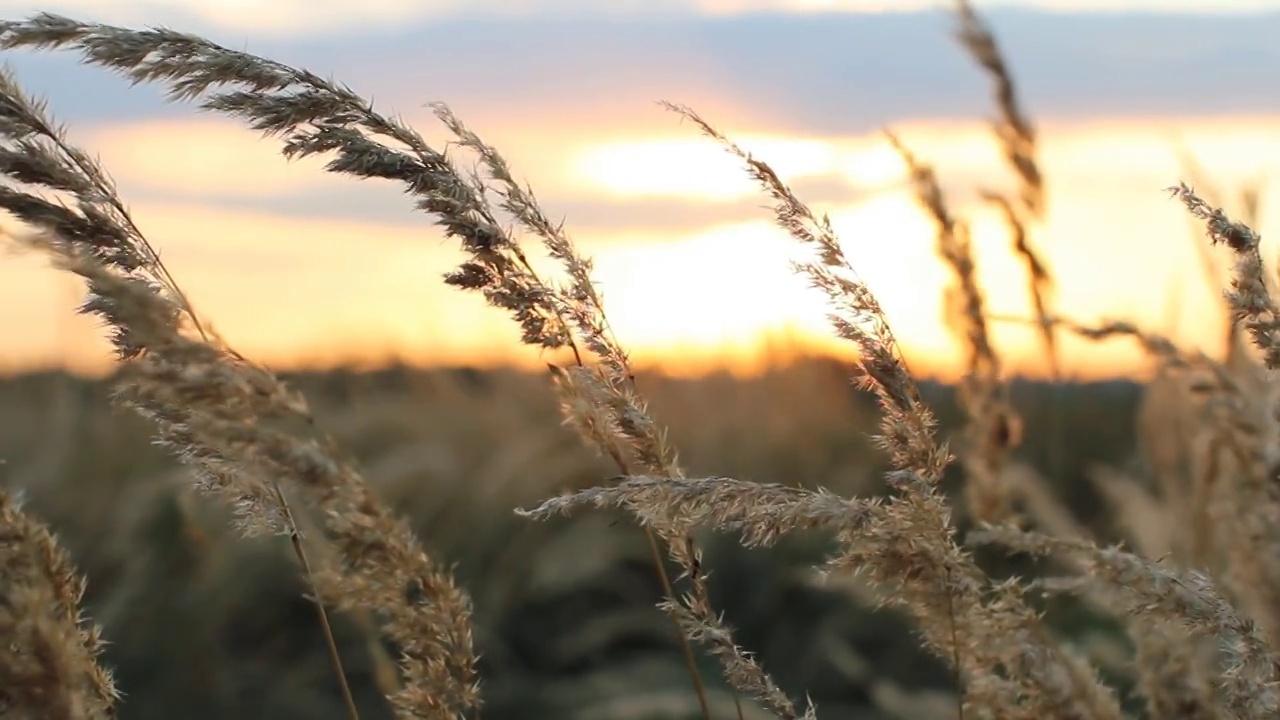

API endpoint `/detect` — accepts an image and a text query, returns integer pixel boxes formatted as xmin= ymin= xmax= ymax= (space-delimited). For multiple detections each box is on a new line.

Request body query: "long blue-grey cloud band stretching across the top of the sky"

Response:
xmin=8 ymin=8 xmax=1280 ymax=136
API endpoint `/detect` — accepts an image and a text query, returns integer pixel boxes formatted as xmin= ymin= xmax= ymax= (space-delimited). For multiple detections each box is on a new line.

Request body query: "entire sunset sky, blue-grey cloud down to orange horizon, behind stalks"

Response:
xmin=0 ymin=0 xmax=1280 ymax=378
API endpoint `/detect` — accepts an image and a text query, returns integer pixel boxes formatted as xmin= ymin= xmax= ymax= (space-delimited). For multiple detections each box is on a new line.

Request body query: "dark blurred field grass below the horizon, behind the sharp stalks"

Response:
xmin=0 ymin=359 xmax=1140 ymax=720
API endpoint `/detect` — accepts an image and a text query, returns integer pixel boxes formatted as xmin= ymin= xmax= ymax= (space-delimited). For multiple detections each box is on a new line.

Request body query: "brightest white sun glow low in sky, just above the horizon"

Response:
xmin=568 ymin=188 xmax=952 ymax=364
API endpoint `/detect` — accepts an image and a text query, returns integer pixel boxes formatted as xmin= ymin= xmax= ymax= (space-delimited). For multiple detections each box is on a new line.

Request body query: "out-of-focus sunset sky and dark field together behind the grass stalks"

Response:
xmin=0 ymin=0 xmax=1280 ymax=720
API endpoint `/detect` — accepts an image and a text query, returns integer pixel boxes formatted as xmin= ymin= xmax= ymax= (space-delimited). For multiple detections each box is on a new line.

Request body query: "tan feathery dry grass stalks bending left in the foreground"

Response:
xmin=0 ymin=3 xmax=1280 ymax=720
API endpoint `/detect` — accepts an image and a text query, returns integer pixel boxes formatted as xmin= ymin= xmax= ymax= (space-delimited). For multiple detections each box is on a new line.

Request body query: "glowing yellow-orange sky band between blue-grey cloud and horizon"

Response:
xmin=0 ymin=7 xmax=1280 ymax=377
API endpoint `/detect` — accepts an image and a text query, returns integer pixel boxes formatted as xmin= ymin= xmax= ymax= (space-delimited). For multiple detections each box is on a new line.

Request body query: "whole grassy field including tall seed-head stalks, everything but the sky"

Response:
xmin=0 ymin=3 xmax=1280 ymax=720
